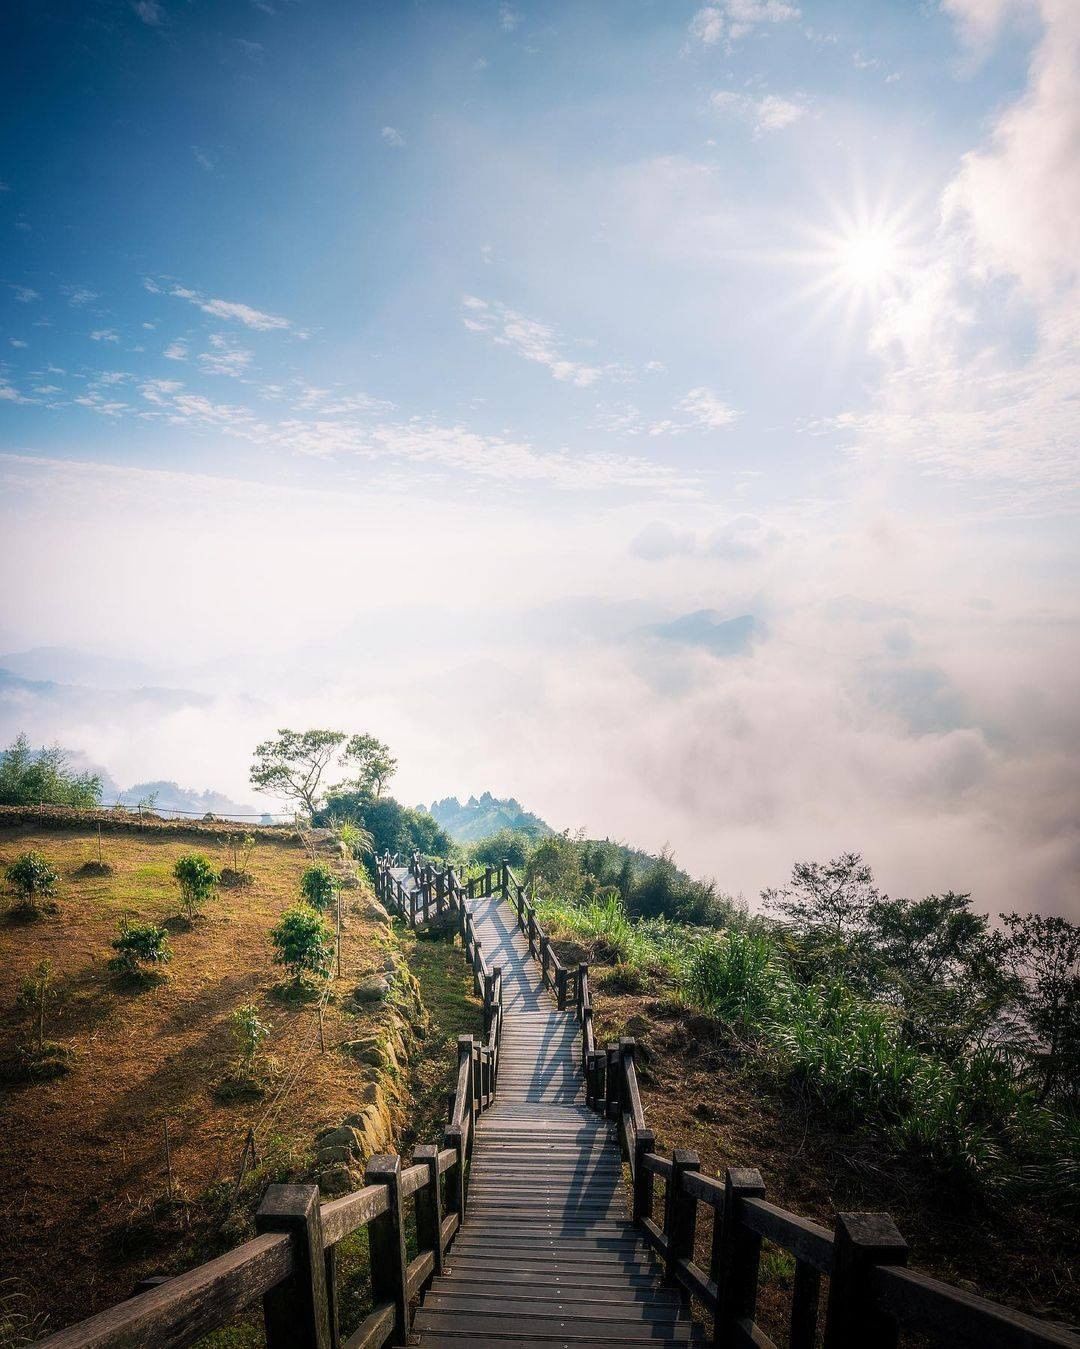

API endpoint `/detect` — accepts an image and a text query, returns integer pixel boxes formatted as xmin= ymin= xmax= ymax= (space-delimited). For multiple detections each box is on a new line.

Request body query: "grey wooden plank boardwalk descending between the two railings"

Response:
xmin=414 ymin=896 xmax=698 ymax=1349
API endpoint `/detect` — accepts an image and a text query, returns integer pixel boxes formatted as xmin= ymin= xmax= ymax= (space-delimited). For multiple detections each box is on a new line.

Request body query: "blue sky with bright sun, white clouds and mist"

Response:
xmin=0 ymin=0 xmax=1080 ymax=917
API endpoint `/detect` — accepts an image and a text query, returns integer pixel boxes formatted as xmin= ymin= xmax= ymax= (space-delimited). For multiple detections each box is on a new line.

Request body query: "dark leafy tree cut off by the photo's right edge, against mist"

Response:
xmin=1000 ymin=913 xmax=1080 ymax=1101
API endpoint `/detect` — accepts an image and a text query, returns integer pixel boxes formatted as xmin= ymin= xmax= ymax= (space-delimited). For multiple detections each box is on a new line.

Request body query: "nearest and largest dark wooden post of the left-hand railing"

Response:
xmin=255 ymin=1184 xmax=330 ymax=1349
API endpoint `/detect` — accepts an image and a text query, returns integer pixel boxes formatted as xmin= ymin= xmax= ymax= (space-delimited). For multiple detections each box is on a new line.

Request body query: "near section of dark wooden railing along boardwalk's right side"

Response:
xmin=585 ymin=1039 xmax=1080 ymax=1349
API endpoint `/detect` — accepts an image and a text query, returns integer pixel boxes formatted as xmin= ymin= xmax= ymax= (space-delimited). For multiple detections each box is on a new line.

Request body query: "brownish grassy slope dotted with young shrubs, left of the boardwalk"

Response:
xmin=0 ymin=824 xmax=399 ymax=1342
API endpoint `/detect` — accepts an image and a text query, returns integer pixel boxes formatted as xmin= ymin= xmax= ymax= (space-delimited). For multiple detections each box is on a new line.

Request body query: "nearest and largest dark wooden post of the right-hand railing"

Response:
xmin=825 ymin=1213 xmax=907 ymax=1349
